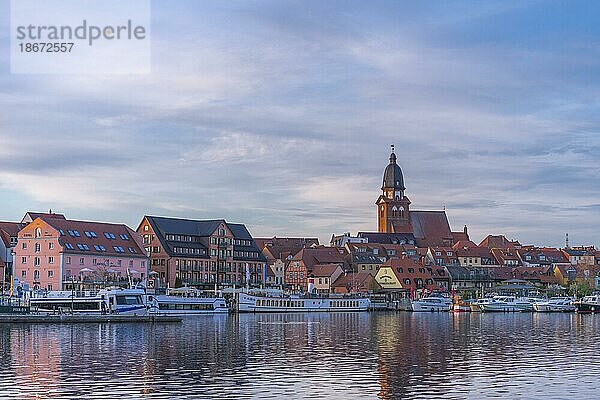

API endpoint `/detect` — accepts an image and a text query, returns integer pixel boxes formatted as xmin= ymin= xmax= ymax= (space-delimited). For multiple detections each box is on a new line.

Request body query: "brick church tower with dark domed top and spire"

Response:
xmin=375 ymin=145 xmax=412 ymax=233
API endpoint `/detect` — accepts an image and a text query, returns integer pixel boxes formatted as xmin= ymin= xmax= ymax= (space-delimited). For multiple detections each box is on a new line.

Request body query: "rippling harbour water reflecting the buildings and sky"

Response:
xmin=0 ymin=312 xmax=600 ymax=400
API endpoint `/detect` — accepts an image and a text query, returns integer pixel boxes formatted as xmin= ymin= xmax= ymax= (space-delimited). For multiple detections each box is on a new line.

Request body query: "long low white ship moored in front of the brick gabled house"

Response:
xmin=236 ymin=293 xmax=371 ymax=312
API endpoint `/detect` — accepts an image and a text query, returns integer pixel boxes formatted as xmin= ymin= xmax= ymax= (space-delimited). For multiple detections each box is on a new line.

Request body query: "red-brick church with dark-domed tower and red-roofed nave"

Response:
xmin=359 ymin=145 xmax=468 ymax=247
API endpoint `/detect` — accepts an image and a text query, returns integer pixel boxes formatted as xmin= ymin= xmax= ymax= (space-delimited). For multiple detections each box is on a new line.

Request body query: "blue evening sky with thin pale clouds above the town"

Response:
xmin=0 ymin=0 xmax=600 ymax=246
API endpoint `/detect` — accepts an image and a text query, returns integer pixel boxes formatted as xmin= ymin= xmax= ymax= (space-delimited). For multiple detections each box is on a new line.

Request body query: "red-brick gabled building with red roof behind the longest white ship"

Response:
xmin=285 ymin=246 xmax=350 ymax=292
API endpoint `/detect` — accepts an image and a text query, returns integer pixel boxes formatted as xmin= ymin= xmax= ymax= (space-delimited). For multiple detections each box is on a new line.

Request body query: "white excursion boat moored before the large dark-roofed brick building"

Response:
xmin=148 ymin=288 xmax=229 ymax=315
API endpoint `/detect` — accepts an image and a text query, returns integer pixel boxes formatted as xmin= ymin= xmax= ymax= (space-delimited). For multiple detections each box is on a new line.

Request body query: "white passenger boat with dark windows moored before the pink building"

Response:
xmin=29 ymin=288 xmax=148 ymax=315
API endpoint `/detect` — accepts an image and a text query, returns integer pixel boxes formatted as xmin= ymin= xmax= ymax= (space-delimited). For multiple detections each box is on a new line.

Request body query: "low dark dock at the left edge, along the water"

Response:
xmin=0 ymin=314 xmax=182 ymax=324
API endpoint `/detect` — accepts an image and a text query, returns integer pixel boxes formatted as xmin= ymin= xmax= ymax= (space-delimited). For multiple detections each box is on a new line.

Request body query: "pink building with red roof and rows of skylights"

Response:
xmin=14 ymin=213 xmax=148 ymax=290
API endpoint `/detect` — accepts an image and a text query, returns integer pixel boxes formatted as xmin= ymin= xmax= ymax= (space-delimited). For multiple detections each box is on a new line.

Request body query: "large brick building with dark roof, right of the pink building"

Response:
xmin=137 ymin=215 xmax=266 ymax=289
